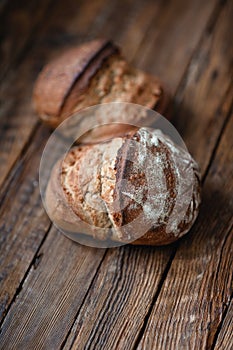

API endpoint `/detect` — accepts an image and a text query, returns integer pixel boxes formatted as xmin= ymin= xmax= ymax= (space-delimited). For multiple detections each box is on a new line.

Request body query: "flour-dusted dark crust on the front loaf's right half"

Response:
xmin=110 ymin=129 xmax=201 ymax=245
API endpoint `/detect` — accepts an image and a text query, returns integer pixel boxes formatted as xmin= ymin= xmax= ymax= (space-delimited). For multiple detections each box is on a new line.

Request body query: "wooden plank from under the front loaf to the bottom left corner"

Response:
xmin=0 ymin=229 xmax=105 ymax=349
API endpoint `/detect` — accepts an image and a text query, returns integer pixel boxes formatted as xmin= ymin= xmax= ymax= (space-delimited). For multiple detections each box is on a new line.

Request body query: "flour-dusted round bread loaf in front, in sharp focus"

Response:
xmin=45 ymin=128 xmax=200 ymax=245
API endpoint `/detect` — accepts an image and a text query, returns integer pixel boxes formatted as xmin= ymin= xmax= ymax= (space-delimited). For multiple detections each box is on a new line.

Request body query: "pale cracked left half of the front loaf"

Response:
xmin=61 ymin=138 xmax=122 ymax=239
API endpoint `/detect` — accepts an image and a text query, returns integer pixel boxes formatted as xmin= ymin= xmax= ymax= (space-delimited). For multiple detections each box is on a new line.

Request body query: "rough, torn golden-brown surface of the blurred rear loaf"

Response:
xmin=73 ymin=55 xmax=163 ymax=116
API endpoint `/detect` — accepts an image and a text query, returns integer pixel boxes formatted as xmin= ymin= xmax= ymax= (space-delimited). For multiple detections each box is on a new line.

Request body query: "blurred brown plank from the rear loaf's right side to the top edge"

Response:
xmin=132 ymin=0 xmax=221 ymax=94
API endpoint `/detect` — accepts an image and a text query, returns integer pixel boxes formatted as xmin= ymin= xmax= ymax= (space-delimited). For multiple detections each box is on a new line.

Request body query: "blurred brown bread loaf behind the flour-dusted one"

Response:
xmin=33 ymin=39 xmax=169 ymax=128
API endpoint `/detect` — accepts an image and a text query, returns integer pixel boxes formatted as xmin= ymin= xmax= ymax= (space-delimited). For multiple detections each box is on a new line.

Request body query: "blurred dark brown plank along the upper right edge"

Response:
xmin=174 ymin=1 xmax=233 ymax=174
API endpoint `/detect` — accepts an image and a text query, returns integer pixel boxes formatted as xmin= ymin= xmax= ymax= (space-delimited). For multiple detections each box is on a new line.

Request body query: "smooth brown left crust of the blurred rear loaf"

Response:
xmin=33 ymin=39 xmax=119 ymax=127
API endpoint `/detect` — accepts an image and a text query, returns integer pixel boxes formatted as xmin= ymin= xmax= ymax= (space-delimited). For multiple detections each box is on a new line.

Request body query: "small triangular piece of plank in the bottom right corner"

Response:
xmin=214 ymin=299 xmax=233 ymax=350
